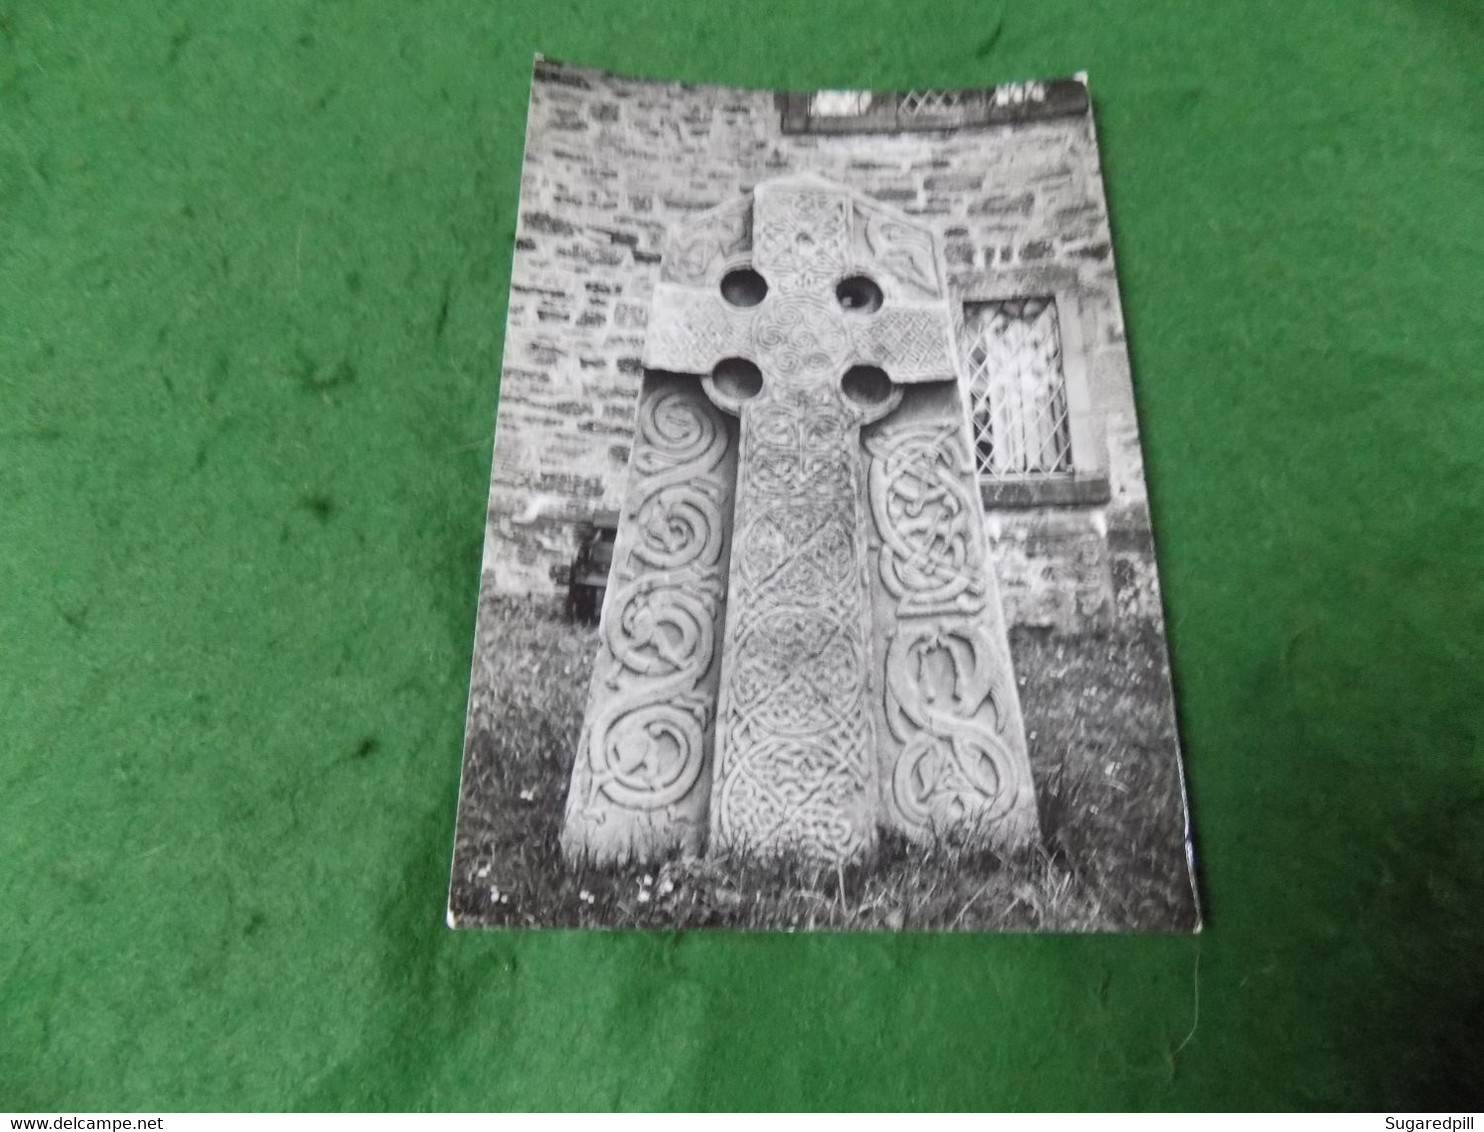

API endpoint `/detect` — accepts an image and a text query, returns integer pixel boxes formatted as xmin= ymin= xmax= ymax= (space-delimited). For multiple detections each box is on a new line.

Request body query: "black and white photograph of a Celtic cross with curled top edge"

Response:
xmin=448 ymin=59 xmax=1201 ymax=932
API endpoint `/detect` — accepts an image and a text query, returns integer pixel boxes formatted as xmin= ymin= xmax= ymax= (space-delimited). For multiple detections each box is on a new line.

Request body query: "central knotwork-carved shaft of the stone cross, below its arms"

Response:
xmin=712 ymin=385 xmax=879 ymax=860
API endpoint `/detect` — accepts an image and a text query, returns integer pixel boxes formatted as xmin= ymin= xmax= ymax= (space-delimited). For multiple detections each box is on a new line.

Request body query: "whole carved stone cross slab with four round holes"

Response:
xmin=562 ymin=177 xmax=1037 ymax=862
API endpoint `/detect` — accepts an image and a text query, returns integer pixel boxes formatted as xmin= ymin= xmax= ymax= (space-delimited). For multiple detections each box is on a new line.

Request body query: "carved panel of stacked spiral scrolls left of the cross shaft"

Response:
xmin=562 ymin=375 xmax=733 ymax=859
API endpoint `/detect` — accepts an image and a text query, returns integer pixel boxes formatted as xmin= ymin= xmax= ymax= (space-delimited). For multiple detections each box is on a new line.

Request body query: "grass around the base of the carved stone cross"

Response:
xmin=450 ymin=598 xmax=1195 ymax=932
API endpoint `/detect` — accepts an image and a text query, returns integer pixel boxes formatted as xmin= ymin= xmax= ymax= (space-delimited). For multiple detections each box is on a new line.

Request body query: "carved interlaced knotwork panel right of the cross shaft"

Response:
xmin=865 ymin=386 xmax=1039 ymax=846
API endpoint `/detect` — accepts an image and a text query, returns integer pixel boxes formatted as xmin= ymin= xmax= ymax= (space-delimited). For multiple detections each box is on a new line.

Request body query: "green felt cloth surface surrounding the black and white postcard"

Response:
xmin=0 ymin=0 xmax=1484 ymax=1111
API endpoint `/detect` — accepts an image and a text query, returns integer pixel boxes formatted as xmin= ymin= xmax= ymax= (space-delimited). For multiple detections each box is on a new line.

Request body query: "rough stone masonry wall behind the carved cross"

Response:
xmin=485 ymin=62 xmax=1159 ymax=631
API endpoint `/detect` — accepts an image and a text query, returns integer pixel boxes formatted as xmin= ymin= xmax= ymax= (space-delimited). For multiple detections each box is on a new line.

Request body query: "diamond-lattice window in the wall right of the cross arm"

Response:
xmin=965 ymin=297 xmax=1071 ymax=479
